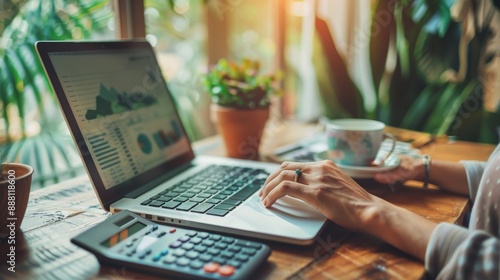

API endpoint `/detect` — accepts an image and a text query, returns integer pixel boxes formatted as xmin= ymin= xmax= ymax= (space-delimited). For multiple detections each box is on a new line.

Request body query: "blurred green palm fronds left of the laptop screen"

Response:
xmin=0 ymin=0 xmax=112 ymax=189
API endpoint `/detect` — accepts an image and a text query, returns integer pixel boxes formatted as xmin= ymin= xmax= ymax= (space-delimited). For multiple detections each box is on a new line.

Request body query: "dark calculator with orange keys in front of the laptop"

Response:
xmin=71 ymin=210 xmax=271 ymax=279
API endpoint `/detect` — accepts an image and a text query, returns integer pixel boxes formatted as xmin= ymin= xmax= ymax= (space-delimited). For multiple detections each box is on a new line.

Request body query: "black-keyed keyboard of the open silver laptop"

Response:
xmin=141 ymin=165 xmax=269 ymax=216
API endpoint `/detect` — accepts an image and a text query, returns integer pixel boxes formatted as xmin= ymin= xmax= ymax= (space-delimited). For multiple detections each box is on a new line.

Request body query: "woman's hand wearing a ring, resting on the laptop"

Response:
xmin=259 ymin=160 xmax=380 ymax=230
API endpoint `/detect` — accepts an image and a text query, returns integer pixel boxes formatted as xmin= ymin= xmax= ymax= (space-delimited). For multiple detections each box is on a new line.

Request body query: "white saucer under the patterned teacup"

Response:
xmin=314 ymin=151 xmax=400 ymax=179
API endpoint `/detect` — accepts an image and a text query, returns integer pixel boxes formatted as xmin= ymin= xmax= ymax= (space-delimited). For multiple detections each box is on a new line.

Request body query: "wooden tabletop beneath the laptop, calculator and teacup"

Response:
xmin=0 ymin=121 xmax=494 ymax=279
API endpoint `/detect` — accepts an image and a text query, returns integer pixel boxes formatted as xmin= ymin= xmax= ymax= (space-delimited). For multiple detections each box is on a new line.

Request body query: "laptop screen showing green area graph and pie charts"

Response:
xmin=37 ymin=42 xmax=191 ymax=208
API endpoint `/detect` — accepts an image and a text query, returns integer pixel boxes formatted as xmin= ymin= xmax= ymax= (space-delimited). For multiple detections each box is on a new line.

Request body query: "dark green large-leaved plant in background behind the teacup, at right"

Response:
xmin=320 ymin=0 xmax=500 ymax=142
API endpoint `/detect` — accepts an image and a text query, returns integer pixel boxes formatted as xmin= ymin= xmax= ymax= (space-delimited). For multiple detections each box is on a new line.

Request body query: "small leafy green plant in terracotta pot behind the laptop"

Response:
xmin=204 ymin=59 xmax=281 ymax=160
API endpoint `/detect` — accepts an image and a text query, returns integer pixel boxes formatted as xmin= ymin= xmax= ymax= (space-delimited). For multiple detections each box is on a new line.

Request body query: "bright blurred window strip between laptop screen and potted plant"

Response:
xmin=144 ymin=0 xmax=214 ymax=140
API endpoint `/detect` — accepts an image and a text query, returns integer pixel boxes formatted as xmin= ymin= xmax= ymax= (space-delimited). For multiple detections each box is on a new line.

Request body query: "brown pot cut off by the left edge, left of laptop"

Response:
xmin=0 ymin=163 xmax=33 ymax=237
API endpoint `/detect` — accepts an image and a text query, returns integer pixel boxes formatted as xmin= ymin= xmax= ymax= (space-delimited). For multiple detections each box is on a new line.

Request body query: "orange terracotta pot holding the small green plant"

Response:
xmin=210 ymin=104 xmax=269 ymax=160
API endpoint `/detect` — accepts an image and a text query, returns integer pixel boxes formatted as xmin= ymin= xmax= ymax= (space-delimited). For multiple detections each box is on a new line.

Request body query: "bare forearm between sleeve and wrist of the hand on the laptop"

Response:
xmin=363 ymin=198 xmax=436 ymax=261
